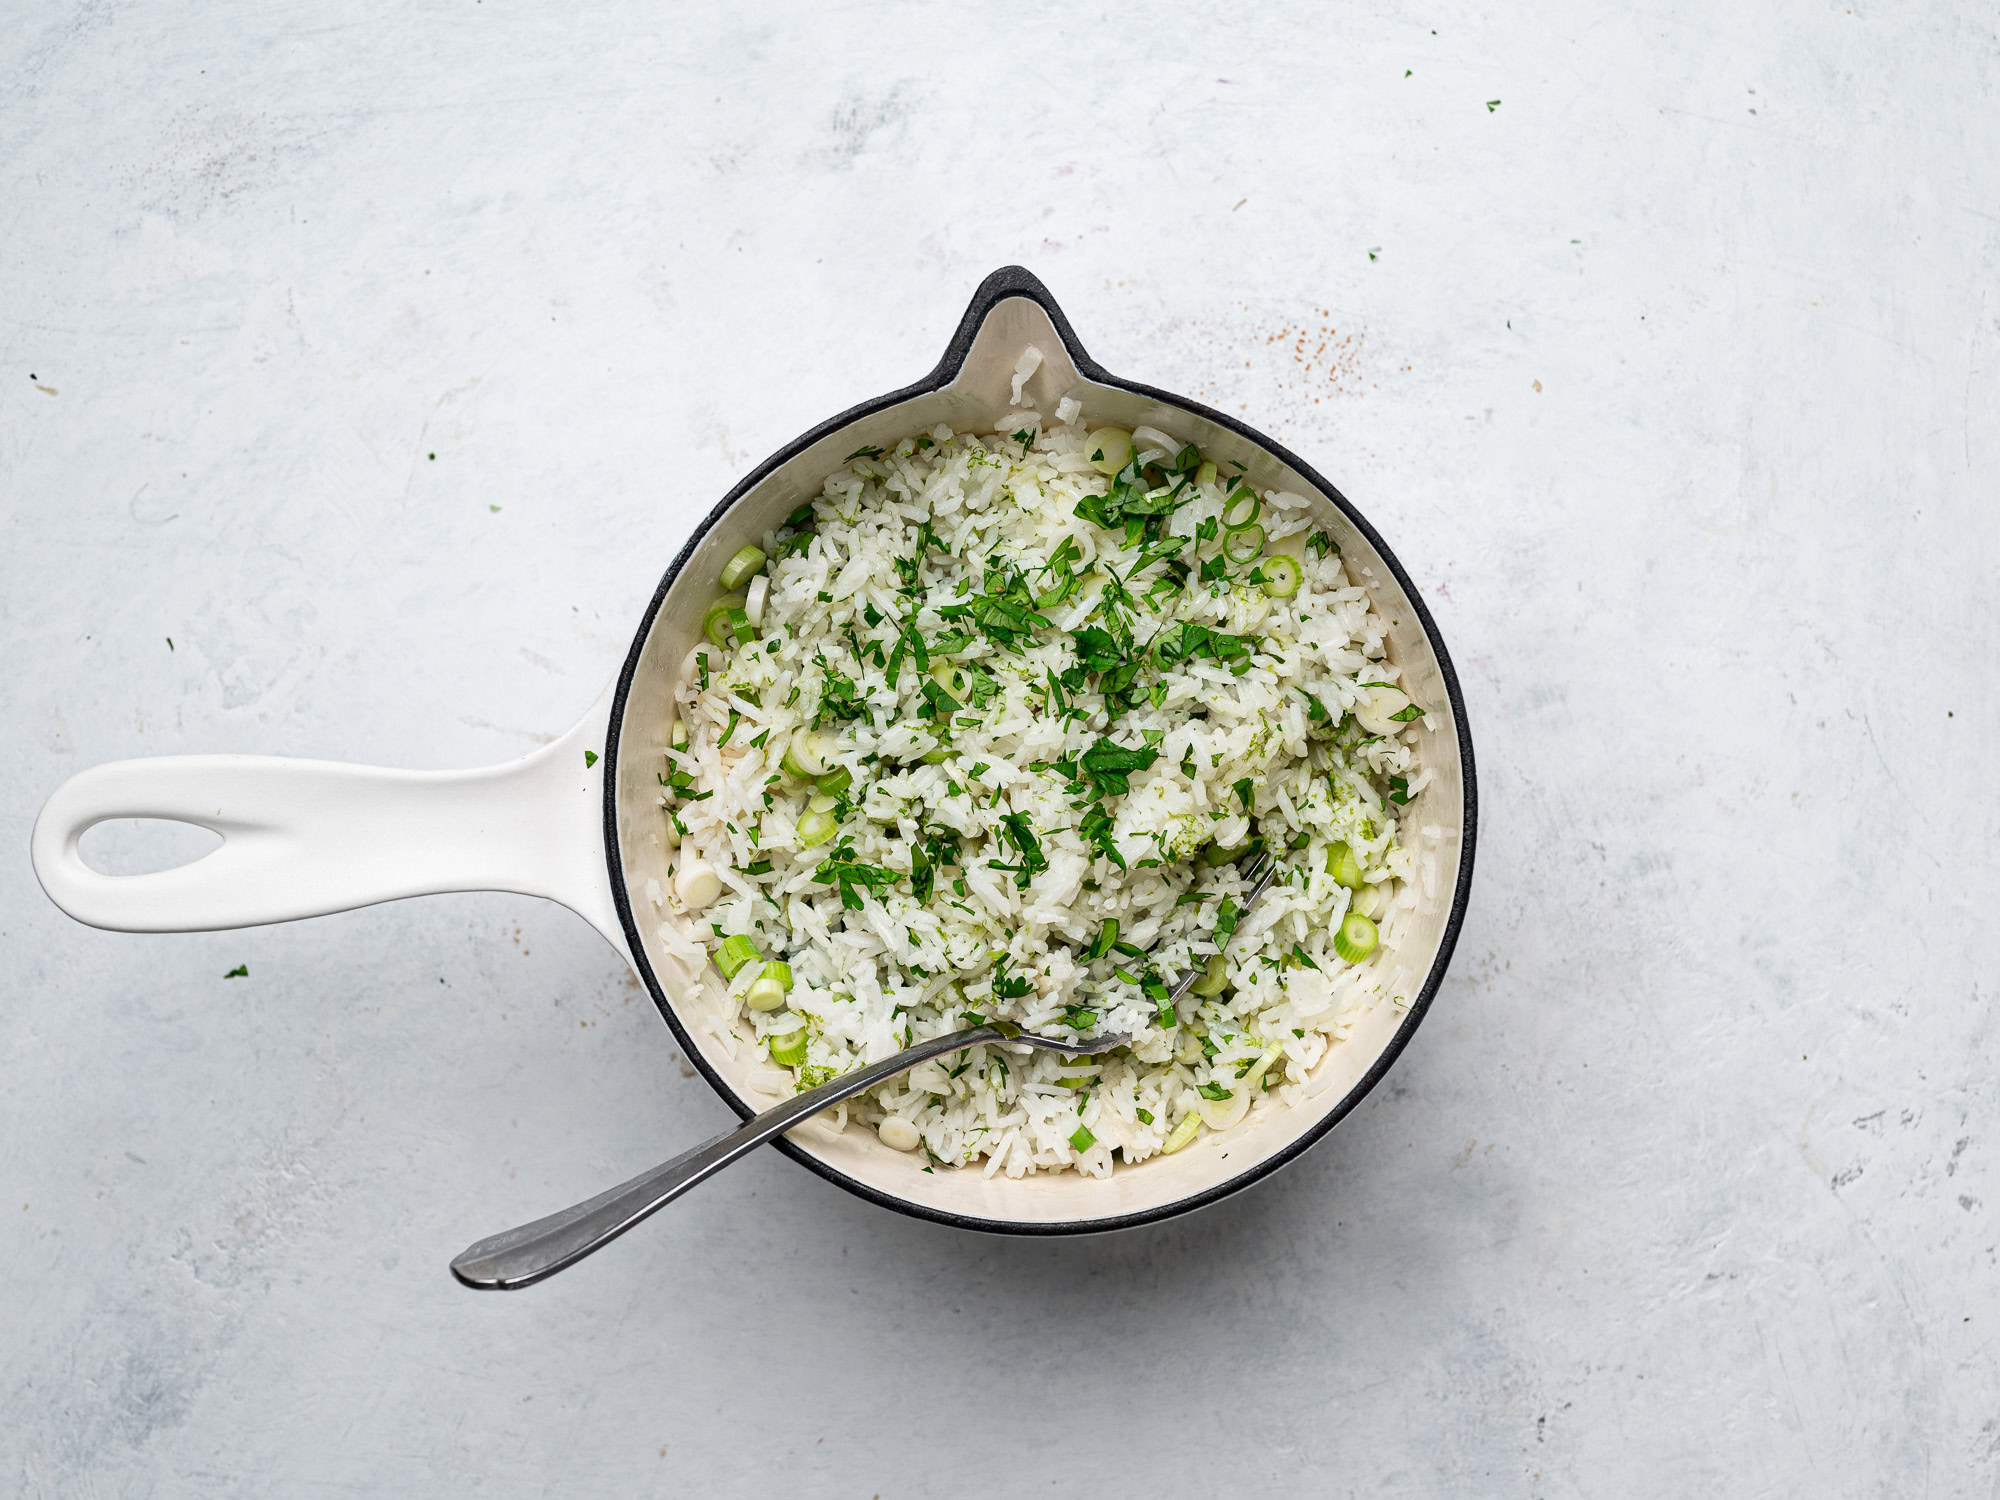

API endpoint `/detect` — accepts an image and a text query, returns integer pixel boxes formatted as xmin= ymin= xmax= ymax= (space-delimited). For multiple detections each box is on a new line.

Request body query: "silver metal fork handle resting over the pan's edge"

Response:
xmin=452 ymin=1026 xmax=1006 ymax=1292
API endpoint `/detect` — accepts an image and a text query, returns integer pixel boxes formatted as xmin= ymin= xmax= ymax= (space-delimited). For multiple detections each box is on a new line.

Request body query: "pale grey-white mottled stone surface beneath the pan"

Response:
xmin=0 ymin=0 xmax=2000 ymax=1496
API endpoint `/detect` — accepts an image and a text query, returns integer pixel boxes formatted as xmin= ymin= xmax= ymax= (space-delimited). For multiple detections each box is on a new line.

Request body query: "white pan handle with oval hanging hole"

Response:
xmin=30 ymin=690 xmax=626 ymax=952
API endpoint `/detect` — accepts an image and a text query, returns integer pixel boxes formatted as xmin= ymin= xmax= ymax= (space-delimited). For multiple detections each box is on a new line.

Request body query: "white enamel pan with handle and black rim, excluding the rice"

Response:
xmin=32 ymin=266 xmax=1476 ymax=1234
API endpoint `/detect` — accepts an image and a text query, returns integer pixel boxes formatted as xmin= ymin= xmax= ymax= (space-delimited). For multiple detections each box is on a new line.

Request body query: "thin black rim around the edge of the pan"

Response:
xmin=602 ymin=266 xmax=1478 ymax=1236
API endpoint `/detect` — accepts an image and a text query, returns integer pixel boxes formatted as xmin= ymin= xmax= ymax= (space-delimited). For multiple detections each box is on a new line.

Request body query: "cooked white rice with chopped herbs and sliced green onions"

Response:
xmin=654 ymin=366 xmax=1428 ymax=1176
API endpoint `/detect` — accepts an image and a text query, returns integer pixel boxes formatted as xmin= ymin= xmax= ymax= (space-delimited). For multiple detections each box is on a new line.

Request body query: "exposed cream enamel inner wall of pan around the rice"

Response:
xmin=618 ymin=298 xmax=1464 ymax=1224
